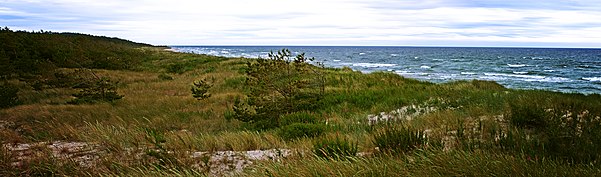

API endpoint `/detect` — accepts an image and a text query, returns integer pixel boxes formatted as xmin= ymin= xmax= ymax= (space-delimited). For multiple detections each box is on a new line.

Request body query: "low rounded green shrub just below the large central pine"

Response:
xmin=278 ymin=123 xmax=326 ymax=140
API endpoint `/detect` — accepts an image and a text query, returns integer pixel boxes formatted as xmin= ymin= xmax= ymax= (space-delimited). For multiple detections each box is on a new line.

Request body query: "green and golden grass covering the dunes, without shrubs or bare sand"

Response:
xmin=0 ymin=48 xmax=601 ymax=176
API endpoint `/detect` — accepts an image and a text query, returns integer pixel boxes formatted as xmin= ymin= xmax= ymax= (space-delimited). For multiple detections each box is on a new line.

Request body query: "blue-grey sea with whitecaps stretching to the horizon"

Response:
xmin=172 ymin=46 xmax=601 ymax=94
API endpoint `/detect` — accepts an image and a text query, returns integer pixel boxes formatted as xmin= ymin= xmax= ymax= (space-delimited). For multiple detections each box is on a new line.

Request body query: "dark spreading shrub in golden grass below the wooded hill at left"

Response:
xmin=69 ymin=77 xmax=123 ymax=104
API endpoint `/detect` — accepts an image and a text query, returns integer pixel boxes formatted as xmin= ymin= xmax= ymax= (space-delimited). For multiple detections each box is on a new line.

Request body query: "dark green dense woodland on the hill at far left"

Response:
xmin=0 ymin=27 xmax=151 ymax=79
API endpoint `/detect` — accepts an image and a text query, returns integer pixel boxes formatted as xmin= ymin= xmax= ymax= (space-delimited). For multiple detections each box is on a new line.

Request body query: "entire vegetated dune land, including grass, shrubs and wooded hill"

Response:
xmin=0 ymin=28 xmax=601 ymax=176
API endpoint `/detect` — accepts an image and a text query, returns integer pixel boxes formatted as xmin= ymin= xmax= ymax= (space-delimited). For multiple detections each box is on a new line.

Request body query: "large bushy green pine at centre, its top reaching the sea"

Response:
xmin=235 ymin=49 xmax=324 ymax=128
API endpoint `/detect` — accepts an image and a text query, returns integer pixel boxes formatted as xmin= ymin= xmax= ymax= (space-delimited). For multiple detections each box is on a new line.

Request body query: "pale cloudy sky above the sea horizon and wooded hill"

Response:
xmin=0 ymin=0 xmax=601 ymax=48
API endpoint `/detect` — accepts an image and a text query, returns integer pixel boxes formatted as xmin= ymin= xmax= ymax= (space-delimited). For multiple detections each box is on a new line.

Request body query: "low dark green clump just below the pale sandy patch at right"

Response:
xmin=373 ymin=126 xmax=428 ymax=153
